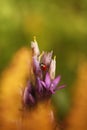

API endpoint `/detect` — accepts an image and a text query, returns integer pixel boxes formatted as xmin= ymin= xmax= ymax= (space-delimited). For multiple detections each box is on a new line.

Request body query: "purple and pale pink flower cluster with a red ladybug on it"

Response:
xmin=23 ymin=38 xmax=64 ymax=106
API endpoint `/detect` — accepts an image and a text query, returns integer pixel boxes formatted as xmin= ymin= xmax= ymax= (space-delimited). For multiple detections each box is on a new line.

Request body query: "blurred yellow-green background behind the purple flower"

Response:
xmin=0 ymin=0 xmax=87 ymax=127
